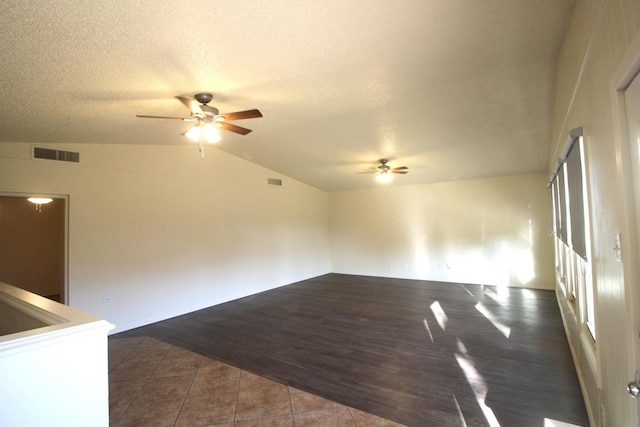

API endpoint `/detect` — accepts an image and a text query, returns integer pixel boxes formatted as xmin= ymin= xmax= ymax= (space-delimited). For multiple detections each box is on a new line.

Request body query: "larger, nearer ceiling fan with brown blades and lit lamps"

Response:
xmin=136 ymin=93 xmax=262 ymax=157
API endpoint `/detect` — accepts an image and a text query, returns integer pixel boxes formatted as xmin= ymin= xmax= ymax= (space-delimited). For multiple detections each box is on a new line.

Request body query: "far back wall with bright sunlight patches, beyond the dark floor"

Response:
xmin=329 ymin=174 xmax=555 ymax=289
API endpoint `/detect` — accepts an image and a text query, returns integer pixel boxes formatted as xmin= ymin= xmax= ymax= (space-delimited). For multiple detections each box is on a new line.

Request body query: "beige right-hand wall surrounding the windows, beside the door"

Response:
xmin=549 ymin=0 xmax=640 ymax=426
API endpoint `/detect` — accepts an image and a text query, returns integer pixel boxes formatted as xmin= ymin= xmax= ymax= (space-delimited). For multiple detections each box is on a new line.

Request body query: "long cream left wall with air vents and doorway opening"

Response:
xmin=0 ymin=144 xmax=330 ymax=332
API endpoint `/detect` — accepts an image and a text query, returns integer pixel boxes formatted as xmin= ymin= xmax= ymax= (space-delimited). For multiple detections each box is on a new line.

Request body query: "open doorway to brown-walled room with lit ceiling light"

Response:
xmin=0 ymin=193 xmax=68 ymax=304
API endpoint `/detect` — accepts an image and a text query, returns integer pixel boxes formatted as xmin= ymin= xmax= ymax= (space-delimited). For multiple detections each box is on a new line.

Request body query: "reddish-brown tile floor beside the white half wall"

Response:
xmin=109 ymin=337 xmax=400 ymax=427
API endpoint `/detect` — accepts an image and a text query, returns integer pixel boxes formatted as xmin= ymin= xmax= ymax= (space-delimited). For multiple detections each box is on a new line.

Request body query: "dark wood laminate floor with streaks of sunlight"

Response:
xmin=120 ymin=274 xmax=589 ymax=427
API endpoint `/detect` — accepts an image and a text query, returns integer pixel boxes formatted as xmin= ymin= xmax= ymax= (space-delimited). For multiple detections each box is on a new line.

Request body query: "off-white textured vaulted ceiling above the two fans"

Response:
xmin=0 ymin=0 xmax=575 ymax=191
